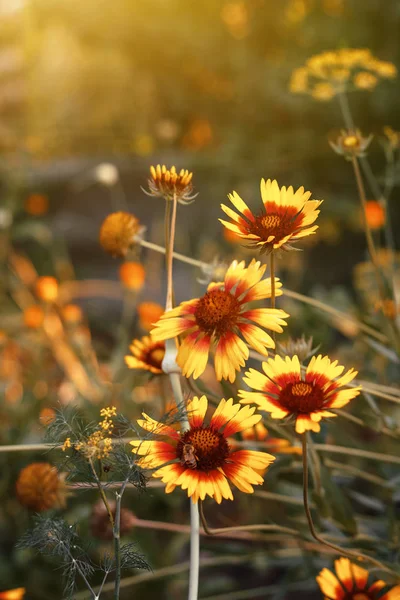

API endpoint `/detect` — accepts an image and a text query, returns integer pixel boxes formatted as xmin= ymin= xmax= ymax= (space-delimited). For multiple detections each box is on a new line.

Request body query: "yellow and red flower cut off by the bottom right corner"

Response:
xmin=317 ymin=557 xmax=400 ymax=600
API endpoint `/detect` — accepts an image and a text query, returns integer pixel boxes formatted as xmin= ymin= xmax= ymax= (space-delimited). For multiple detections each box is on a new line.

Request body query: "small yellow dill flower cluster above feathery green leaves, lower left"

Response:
xmin=62 ymin=406 xmax=117 ymax=459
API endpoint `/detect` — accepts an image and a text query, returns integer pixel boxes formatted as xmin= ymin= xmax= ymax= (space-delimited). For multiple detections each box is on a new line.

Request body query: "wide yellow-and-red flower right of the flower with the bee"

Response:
xmin=239 ymin=354 xmax=361 ymax=433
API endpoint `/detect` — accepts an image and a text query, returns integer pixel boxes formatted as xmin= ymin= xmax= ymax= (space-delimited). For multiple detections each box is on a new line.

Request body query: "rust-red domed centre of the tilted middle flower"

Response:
xmin=194 ymin=290 xmax=240 ymax=336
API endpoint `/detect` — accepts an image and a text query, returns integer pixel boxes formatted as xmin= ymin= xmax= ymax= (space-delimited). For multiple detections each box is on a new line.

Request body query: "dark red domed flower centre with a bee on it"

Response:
xmin=176 ymin=427 xmax=230 ymax=472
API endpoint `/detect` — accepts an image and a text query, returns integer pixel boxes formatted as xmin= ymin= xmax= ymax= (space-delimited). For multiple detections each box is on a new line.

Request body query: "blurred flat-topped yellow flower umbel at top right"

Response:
xmin=290 ymin=48 xmax=397 ymax=101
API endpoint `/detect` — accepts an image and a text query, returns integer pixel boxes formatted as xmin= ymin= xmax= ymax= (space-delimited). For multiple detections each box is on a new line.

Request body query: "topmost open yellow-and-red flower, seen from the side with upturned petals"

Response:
xmin=220 ymin=179 xmax=322 ymax=252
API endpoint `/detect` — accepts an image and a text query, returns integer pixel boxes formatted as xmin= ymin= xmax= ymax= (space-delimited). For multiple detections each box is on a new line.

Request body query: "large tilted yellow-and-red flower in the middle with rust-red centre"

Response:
xmin=151 ymin=260 xmax=289 ymax=382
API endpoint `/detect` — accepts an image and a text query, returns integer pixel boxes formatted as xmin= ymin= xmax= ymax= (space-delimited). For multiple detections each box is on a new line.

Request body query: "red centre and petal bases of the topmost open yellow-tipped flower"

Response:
xmin=247 ymin=206 xmax=300 ymax=246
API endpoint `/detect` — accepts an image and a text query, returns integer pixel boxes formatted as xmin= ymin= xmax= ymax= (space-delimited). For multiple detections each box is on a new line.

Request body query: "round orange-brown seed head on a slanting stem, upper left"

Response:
xmin=99 ymin=211 xmax=143 ymax=257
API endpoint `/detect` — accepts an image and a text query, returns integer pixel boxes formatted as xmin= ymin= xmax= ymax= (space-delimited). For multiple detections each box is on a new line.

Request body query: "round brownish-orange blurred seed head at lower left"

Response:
xmin=16 ymin=462 xmax=66 ymax=512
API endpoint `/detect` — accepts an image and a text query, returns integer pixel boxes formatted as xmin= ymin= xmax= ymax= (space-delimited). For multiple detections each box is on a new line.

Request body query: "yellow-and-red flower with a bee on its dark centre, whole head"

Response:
xmin=130 ymin=396 xmax=275 ymax=504
